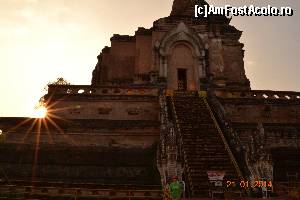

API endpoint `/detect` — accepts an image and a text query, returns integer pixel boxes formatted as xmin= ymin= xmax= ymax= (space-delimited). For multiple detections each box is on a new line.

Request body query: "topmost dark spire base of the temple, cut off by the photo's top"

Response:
xmin=171 ymin=0 xmax=207 ymax=16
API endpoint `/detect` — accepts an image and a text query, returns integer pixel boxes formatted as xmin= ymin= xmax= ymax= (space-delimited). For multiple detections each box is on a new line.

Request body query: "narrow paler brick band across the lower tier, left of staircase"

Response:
xmin=4 ymin=128 xmax=159 ymax=148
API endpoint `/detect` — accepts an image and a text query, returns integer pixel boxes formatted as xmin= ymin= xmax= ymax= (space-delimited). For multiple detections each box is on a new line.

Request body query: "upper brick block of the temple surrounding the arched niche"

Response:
xmin=92 ymin=10 xmax=249 ymax=90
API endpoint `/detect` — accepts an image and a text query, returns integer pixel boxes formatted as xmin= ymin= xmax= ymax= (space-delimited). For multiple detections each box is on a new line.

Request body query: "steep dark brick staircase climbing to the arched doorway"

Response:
xmin=172 ymin=92 xmax=238 ymax=197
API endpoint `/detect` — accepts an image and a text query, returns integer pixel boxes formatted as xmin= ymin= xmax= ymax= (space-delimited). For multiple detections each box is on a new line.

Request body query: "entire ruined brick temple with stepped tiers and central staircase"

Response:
xmin=0 ymin=0 xmax=300 ymax=199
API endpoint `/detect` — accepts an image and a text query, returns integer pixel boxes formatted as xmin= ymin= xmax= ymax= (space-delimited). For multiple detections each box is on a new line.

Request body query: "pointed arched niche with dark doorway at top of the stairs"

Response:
xmin=159 ymin=22 xmax=205 ymax=90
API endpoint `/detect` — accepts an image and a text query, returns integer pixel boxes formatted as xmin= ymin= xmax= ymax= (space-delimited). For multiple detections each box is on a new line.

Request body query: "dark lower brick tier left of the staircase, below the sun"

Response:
xmin=0 ymin=118 xmax=160 ymax=185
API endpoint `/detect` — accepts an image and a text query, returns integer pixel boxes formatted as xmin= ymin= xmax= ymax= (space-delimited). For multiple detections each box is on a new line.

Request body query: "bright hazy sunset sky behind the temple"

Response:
xmin=0 ymin=0 xmax=300 ymax=117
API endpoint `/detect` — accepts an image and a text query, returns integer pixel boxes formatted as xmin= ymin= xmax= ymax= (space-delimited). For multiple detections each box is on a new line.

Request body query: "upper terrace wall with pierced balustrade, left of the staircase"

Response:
xmin=45 ymin=85 xmax=159 ymax=121
